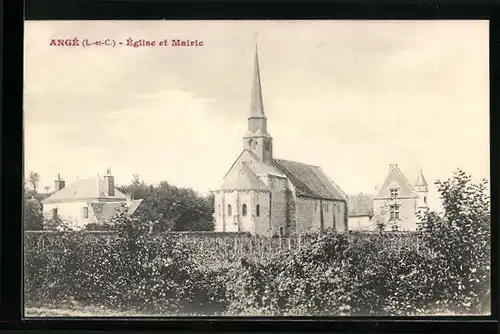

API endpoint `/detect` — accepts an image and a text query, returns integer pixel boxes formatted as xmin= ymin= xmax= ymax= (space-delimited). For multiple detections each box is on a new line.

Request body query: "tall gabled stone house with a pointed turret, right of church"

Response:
xmin=373 ymin=164 xmax=429 ymax=231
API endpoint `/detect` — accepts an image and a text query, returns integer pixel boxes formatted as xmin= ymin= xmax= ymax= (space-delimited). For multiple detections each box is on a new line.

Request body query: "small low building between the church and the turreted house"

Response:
xmin=347 ymin=193 xmax=373 ymax=231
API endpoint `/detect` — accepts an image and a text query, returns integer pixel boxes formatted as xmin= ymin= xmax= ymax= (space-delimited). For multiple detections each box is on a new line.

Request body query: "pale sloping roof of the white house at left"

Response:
xmin=42 ymin=177 xmax=125 ymax=203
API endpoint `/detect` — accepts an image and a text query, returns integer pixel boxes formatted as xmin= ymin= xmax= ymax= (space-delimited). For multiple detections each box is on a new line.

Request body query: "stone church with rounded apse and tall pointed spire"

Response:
xmin=213 ymin=48 xmax=347 ymax=236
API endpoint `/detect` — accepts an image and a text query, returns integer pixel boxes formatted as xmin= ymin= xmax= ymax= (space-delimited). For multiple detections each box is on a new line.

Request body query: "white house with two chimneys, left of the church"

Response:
xmin=42 ymin=169 xmax=149 ymax=228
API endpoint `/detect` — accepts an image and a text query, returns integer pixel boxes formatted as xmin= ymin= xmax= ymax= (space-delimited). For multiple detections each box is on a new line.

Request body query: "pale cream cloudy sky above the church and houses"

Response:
xmin=24 ymin=20 xmax=489 ymax=207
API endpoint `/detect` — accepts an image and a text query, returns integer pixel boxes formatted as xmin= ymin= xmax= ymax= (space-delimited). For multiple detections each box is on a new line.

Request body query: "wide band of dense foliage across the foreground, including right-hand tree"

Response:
xmin=25 ymin=173 xmax=490 ymax=316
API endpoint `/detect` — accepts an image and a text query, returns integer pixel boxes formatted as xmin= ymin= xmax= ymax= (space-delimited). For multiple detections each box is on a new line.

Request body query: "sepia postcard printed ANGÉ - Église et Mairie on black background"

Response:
xmin=23 ymin=20 xmax=491 ymax=317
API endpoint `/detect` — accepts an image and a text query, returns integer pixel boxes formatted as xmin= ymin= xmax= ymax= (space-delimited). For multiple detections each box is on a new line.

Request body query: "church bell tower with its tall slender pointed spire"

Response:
xmin=243 ymin=45 xmax=273 ymax=163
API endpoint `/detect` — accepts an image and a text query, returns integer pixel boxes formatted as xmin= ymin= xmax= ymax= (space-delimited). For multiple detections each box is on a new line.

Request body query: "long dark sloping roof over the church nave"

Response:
xmin=273 ymin=159 xmax=347 ymax=200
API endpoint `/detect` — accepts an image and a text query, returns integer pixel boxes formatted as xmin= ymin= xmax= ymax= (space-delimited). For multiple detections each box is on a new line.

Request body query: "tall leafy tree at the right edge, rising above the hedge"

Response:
xmin=420 ymin=170 xmax=491 ymax=313
